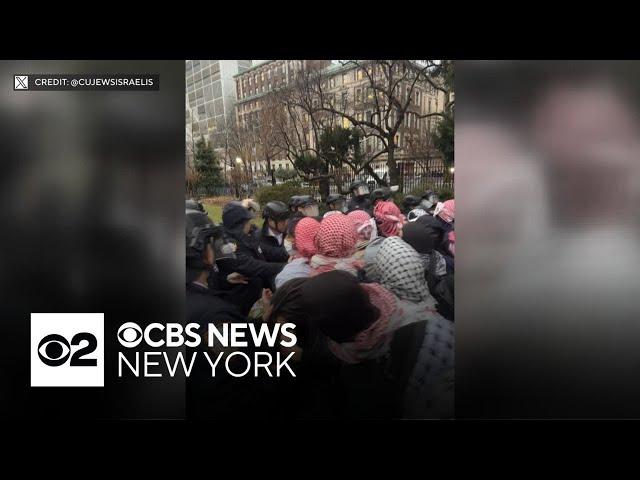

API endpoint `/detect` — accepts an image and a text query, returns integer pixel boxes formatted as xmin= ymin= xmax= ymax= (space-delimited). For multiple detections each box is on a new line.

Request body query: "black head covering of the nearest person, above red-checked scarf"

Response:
xmin=302 ymin=270 xmax=380 ymax=343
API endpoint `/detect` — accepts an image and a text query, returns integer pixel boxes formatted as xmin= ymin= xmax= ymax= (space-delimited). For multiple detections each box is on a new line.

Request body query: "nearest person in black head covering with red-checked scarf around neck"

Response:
xmin=301 ymin=271 xmax=454 ymax=418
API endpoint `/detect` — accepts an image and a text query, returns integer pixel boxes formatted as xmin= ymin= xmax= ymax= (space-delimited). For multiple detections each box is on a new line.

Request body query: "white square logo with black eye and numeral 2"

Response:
xmin=31 ymin=313 xmax=104 ymax=387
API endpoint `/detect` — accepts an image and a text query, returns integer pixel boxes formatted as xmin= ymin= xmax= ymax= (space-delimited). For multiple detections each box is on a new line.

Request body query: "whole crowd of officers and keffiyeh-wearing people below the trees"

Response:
xmin=186 ymin=181 xmax=455 ymax=418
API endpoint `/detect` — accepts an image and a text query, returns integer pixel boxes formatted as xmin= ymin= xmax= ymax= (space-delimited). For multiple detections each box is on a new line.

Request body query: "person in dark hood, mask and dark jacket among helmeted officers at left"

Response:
xmin=219 ymin=201 xmax=285 ymax=302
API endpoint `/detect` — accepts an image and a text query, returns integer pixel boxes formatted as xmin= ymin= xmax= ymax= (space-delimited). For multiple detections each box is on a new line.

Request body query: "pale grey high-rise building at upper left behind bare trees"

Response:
xmin=185 ymin=60 xmax=252 ymax=147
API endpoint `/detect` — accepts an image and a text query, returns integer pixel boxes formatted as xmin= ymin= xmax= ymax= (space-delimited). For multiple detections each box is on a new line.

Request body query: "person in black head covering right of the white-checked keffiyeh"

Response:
xmin=402 ymin=217 xmax=454 ymax=321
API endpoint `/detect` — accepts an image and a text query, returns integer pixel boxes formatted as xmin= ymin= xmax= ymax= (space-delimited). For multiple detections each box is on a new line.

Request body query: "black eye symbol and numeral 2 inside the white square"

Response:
xmin=38 ymin=332 xmax=98 ymax=367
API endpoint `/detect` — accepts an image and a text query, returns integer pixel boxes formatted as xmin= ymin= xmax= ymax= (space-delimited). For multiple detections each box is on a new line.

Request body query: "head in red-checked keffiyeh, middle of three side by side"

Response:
xmin=309 ymin=215 xmax=362 ymax=276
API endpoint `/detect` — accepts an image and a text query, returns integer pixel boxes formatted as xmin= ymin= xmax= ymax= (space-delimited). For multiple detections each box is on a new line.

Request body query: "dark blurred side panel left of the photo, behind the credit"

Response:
xmin=0 ymin=61 xmax=184 ymax=418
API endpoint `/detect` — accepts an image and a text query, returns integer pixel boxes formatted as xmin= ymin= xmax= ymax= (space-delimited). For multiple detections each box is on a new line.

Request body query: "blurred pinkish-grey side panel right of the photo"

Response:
xmin=455 ymin=61 xmax=640 ymax=418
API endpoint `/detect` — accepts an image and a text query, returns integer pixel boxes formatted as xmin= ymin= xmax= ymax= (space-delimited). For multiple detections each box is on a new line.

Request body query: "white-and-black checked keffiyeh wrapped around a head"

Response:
xmin=375 ymin=237 xmax=435 ymax=303
